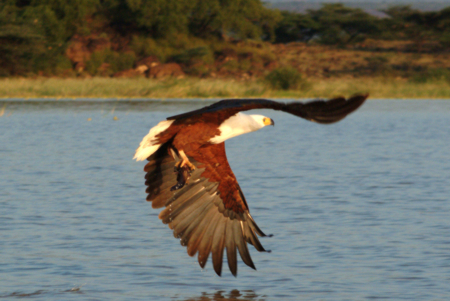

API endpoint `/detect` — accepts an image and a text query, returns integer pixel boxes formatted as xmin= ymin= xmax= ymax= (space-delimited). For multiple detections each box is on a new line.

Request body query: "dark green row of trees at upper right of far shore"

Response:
xmin=275 ymin=3 xmax=450 ymax=47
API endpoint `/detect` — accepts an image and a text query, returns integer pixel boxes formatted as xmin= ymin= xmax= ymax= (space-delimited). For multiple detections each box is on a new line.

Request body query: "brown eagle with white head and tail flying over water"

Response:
xmin=134 ymin=95 xmax=368 ymax=276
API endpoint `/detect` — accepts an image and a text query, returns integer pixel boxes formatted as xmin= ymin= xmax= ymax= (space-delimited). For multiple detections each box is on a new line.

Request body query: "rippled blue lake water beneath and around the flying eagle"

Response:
xmin=0 ymin=99 xmax=450 ymax=300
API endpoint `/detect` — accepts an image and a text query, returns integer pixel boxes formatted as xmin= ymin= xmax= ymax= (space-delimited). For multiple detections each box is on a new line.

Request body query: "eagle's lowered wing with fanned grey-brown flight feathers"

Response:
xmin=144 ymin=143 xmax=266 ymax=276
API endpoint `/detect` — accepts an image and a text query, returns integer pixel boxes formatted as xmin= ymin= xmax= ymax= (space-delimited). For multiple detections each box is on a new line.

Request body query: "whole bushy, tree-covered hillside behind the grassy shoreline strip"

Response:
xmin=0 ymin=0 xmax=450 ymax=97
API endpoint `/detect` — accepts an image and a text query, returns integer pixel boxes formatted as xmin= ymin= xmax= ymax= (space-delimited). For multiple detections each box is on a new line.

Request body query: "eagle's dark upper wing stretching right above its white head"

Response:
xmin=167 ymin=95 xmax=368 ymax=123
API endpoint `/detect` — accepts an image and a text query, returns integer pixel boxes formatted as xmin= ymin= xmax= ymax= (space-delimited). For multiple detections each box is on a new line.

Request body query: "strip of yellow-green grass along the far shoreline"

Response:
xmin=0 ymin=77 xmax=450 ymax=98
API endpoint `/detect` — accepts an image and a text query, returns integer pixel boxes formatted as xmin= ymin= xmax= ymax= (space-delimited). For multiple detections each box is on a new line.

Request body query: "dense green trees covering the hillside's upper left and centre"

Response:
xmin=0 ymin=0 xmax=280 ymax=76
